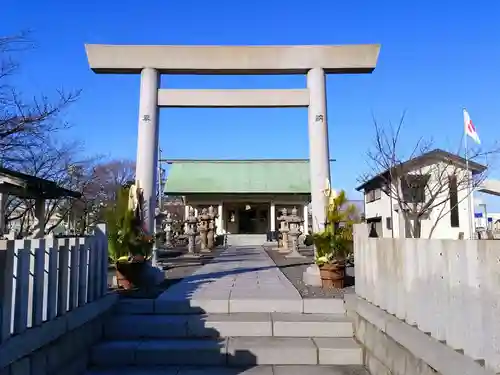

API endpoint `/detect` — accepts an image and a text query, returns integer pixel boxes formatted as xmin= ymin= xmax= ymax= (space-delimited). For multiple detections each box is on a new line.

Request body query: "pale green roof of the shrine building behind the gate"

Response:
xmin=164 ymin=160 xmax=311 ymax=195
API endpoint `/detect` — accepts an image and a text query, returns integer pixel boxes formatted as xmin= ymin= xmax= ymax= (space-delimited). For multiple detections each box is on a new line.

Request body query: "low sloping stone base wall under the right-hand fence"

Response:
xmin=344 ymin=294 xmax=495 ymax=375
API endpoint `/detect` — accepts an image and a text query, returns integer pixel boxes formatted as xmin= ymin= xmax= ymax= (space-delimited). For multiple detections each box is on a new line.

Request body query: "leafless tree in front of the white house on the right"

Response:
xmin=360 ymin=115 xmax=499 ymax=238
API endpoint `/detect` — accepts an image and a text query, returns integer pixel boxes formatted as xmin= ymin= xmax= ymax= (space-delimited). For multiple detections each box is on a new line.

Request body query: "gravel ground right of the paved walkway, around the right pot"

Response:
xmin=264 ymin=247 xmax=354 ymax=298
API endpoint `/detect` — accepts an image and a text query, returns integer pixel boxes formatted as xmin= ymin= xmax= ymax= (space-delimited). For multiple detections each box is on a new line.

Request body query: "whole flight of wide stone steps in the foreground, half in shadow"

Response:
xmin=87 ymin=299 xmax=368 ymax=375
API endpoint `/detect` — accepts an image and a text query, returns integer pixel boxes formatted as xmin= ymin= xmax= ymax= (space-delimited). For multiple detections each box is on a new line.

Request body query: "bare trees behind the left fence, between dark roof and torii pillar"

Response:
xmin=6 ymin=153 xmax=135 ymax=234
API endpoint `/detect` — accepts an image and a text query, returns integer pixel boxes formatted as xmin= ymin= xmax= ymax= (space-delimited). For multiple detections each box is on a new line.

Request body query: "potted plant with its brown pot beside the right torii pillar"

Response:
xmin=313 ymin=191 xmax=357 ymax=288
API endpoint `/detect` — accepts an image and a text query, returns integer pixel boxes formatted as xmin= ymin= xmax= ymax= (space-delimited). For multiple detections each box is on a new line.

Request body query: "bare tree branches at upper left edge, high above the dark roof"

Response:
xmin=0 ymin=33 xmax=80 ymax=163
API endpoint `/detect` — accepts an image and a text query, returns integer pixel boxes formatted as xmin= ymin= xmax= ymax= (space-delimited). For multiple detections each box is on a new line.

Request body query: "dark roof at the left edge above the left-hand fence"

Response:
xmin=0 ymin=167 xmax=82 ymax=199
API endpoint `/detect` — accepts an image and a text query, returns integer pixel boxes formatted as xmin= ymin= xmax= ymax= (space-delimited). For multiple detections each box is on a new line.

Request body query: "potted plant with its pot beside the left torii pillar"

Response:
xmin=105 ymin=187 xmax=153 ymax=289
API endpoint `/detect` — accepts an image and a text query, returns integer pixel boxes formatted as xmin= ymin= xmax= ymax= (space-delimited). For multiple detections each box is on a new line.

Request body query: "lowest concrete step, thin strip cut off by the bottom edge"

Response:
xmin=85 ymin=365 xmax=370 ymax=375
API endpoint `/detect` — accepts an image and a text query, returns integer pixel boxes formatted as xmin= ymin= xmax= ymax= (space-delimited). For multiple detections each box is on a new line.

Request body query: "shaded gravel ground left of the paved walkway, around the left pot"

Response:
xmin=112 ymin=248 xmax=227 ymax=299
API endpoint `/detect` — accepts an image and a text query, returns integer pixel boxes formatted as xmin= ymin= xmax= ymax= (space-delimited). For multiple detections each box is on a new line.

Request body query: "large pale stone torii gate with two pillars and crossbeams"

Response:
xmin=85 ymin=44 xmax=380 ymax=232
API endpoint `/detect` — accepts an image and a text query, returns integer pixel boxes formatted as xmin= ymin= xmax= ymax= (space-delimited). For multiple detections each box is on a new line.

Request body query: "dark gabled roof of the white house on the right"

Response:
xmin=356 ymin=149 xmax=486 ymax=191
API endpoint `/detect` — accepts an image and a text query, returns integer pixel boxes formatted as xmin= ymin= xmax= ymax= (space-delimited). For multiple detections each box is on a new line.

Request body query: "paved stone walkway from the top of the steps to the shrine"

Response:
xmin=155 ymin=246 xmax=302 ymax=313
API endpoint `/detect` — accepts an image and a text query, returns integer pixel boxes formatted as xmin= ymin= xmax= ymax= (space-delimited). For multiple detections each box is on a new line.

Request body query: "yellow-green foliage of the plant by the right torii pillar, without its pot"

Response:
xmin=313 ymin=191 xmax=358 ymax=267
